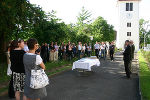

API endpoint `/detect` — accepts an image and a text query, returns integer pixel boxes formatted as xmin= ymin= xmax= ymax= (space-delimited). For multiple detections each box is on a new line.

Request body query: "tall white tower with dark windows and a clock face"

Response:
xmin=116 ymin=0 xmax=141 ymax=51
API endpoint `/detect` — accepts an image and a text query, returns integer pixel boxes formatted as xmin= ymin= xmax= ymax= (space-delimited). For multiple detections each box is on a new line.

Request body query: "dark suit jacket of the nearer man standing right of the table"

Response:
xmin=123 ymin=45 xmax=131 ymax=62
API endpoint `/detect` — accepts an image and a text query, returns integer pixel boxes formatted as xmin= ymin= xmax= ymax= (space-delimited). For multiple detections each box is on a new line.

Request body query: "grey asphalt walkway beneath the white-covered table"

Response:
xmin=0 ymin=53 xmax=140 ymax=100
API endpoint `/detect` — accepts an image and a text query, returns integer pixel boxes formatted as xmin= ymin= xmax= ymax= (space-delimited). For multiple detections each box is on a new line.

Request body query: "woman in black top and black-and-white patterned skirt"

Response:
xmin=10 ymin=40 xmax=26 ymax=100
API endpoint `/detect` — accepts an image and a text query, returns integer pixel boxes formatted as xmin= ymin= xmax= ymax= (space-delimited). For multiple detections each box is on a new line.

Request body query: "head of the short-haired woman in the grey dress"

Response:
xmin=27 ymin=38 xmax=39 ymax=50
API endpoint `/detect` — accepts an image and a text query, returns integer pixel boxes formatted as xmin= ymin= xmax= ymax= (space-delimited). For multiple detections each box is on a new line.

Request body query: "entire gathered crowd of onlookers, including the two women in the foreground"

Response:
xmin=7 ymin=38 xmax=123 ymax=100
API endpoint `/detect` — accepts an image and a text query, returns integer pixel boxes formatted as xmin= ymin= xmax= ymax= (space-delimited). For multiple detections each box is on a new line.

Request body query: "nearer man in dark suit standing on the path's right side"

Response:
xmin=123 ymin=40 xmax=131 ymax=78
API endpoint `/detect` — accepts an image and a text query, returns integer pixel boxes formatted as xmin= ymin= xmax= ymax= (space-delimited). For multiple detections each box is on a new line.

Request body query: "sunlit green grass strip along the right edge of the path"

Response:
xmin=138 ymin=51 xmax=150 ymax=100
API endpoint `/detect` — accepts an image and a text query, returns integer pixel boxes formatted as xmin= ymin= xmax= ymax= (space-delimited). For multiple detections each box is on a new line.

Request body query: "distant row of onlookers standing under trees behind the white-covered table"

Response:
xmin=30 ymin=42 xmax=115 ymax=63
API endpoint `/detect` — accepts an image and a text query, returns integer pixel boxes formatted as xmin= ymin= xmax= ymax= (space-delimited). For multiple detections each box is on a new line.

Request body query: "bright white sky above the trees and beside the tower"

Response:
xmin=30 ymin=0 xmax=150 ymax=29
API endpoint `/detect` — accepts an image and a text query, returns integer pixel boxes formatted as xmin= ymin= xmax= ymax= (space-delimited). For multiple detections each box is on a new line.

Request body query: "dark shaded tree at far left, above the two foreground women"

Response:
xmin=0 ymin=0 xmax=28 ymax=62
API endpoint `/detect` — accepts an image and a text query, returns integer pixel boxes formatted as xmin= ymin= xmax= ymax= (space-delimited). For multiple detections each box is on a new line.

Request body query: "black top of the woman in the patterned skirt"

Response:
xmin=10 ymin=50 xmax=26 ymax=73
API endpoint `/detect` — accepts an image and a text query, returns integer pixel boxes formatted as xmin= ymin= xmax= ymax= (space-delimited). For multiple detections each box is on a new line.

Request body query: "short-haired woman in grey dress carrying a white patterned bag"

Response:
xmin=23 ymin=38 xmax=47 ymax=100
